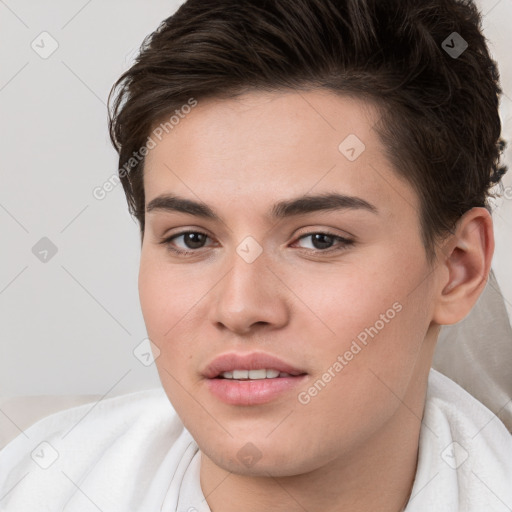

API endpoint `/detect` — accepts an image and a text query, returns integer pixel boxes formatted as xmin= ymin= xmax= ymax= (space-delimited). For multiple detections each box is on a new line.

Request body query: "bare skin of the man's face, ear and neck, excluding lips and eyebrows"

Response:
xmin=139 ymin=90 xmax=494 ymax=512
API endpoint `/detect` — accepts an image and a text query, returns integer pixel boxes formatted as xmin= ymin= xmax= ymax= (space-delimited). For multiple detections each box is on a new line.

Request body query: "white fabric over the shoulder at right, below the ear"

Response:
xmin=407 ymin=369 xmax=512 ymax=512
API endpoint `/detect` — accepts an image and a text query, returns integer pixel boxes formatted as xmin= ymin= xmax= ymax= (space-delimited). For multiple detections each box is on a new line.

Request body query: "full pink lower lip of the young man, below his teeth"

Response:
xmin=207 ymin=375 xmax=306 ymax=405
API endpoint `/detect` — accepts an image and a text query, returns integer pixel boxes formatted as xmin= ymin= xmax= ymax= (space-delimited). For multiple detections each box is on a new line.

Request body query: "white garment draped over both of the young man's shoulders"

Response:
xmin=0 ymin=369 xmax=512 ymax=512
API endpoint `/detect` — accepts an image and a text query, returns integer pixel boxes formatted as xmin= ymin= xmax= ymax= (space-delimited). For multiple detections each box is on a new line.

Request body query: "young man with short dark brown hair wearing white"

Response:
xmin=0 ymin=0 xmax=512 ymax=512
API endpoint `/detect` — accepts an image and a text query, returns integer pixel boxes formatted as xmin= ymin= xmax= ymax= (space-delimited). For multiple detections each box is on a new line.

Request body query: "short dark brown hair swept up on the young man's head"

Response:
xmin=109 ymin=0 xmax=507 ymax=262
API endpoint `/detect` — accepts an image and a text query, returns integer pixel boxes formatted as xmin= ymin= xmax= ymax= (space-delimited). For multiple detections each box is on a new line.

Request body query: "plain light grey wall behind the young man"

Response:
xmin=0 ymin=0 xmax=512 ymax=397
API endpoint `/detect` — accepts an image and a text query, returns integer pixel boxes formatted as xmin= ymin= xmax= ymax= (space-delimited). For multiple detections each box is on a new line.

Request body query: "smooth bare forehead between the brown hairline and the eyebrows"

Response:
xmin=144 ymin=90 xmax=418 ymax=220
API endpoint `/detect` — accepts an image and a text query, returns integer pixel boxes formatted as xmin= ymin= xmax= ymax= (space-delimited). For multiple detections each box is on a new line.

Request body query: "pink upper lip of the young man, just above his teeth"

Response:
xmin=203 ymin=352 xmax=306 ymax=379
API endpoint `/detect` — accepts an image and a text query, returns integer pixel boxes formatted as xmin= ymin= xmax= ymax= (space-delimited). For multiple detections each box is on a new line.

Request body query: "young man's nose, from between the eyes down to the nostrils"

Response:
xmin=210 ymin=248 xmax=291 ymax=335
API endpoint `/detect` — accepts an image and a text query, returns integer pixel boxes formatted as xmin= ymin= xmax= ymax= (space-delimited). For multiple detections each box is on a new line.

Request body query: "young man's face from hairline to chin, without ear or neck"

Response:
xmin=139 ymin=91 xmax=435 ymax=475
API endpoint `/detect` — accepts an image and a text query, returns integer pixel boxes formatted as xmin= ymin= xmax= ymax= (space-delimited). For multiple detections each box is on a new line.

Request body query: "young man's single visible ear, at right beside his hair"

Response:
xmin=432 ymin=208 xmax=494 ymax=325
